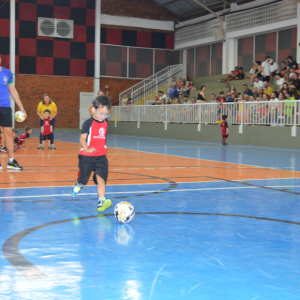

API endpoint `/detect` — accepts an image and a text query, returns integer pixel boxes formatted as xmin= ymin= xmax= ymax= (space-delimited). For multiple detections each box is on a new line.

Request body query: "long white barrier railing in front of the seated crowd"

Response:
xmin=110 ymin=100 xmax=300 ymax=136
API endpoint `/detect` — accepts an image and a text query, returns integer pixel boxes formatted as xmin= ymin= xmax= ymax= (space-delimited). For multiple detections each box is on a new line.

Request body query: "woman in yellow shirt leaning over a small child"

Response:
xmin=37 ymin=94 xmax=57 ymax=149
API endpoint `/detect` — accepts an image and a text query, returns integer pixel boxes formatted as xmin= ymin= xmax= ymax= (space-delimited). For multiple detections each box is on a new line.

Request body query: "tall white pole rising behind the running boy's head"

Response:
xmin=94 ymin=0 xmax=101 ymax=98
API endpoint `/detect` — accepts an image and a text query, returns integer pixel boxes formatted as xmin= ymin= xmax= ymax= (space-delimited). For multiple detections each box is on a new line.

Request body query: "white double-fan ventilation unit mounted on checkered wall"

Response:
xmin=38 ymin=18 xmax=74 ymax=39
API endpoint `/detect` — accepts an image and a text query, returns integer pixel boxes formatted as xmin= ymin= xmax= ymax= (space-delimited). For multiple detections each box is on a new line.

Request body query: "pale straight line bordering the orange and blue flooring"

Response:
xmin=0 ymin=178 xmax=300 ymax=190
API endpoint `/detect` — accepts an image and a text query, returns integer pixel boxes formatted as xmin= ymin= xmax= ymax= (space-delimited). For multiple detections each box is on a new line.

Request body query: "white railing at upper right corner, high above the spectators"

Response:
xmin=226 ymin=0 xmax=297 ymax=32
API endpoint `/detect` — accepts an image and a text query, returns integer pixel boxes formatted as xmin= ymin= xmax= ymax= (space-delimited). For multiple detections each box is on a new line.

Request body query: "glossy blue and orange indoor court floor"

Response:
xmin=0 ymin=131 xmax=300 ymax=300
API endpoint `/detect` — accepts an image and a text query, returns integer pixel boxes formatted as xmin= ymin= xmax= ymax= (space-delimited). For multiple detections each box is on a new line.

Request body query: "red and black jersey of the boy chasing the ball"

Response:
xmin=79 ymin=118 xmax=108 ymax=156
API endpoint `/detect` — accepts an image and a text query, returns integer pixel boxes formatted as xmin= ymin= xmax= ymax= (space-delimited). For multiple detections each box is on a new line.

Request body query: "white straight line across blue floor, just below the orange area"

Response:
xmin=0 ymin=185 xmax=300 ymax=199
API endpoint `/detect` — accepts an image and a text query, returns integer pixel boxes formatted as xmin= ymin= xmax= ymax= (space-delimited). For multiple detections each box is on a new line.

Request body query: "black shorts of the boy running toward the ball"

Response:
xmin=77 ymin=154 xmax=108 ymax=185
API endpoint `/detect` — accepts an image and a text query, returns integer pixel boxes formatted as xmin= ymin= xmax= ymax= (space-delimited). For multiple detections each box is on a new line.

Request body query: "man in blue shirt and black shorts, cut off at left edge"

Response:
xmin=0 ymin=54 xmax=26 ymax=170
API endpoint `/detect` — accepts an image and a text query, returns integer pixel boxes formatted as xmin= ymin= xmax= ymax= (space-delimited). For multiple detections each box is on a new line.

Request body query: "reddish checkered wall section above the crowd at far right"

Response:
xmin=238 ymin=28 xmax=297 ymax=71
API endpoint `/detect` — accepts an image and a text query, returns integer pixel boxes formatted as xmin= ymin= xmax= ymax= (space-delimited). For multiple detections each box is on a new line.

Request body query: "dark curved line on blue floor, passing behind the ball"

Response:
xmin=2 ymin=212 xmax=300 ymax=285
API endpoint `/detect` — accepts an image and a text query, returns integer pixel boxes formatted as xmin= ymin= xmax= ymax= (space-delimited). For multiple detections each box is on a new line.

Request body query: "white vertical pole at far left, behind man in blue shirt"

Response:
xmin=9 ymin=0 xmax=16 ymax=127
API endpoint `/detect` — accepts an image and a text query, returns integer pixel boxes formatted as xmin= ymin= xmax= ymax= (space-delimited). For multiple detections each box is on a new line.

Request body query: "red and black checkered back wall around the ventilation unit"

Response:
xmin=0 ymin=0 xmax=179 ymax=78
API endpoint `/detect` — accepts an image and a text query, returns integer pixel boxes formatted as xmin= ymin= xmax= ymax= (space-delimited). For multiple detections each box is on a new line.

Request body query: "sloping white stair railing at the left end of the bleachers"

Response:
xmin=119 ymin=64 xmax=183 ymax=106
